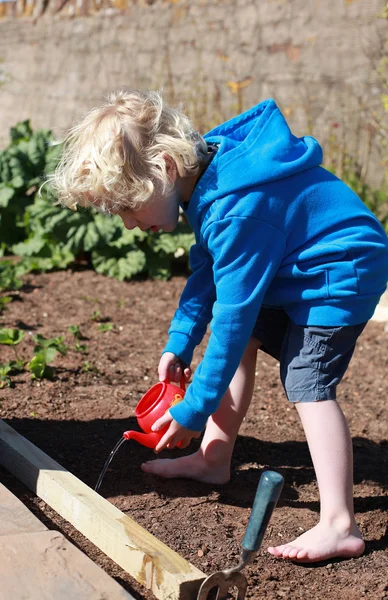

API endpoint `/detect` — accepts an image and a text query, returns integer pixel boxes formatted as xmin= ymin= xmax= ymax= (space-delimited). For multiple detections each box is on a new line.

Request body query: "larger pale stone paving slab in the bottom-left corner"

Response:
xmin=0 ymin=531 xmax=134 ymax=600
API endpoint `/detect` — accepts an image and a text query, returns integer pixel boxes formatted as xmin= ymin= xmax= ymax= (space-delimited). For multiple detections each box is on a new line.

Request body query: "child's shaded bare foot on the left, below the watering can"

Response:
xmin=141 ymin=450 xmax=230 ymax=485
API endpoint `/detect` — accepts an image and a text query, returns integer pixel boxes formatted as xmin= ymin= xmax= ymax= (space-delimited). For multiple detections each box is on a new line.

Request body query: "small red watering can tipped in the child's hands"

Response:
xmin=123 ymin=376 xmax=186 ymax=448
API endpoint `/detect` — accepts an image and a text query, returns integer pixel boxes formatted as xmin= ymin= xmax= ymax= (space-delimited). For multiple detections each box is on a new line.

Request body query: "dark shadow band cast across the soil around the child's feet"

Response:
xmin=6 ymin=418 xmax=388 ymax=520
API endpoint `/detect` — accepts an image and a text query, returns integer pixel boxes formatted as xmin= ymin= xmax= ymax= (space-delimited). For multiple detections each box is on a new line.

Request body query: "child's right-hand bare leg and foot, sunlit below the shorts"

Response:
xmin=268 ymin=400 xmax=365 ymax=562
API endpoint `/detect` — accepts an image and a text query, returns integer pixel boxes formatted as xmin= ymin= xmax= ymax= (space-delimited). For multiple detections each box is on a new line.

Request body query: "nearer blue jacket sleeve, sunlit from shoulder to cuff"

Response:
xmin=170 ymin=217 xmax=285 ymax=431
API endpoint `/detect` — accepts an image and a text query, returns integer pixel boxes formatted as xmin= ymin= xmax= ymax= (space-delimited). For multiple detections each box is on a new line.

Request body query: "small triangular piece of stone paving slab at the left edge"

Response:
xmin=0 ymin=483 xmax=47 ymax=536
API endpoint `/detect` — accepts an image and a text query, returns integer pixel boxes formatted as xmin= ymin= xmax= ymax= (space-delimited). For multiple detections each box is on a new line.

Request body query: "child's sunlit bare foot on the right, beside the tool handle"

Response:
xmin=268 ymin=523 xmax=365 ymax=563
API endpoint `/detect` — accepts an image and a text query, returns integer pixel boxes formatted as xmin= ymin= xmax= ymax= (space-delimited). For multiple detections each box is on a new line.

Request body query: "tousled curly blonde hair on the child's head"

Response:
xmin=49 ymin=90 xmax=207 ymax=212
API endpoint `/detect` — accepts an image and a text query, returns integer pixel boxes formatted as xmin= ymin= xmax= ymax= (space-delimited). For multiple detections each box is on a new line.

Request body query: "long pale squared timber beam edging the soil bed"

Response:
xmin=0 ymin=420 xmax=206 ymax=600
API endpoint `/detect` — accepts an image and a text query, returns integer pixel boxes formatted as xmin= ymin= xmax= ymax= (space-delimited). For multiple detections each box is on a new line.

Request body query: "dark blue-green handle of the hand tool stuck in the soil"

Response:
xmin=242 ymin=471 xmax=284 ymax=562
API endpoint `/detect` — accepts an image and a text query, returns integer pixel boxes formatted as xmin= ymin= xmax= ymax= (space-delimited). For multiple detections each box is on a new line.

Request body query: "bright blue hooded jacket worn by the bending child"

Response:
xmin=164 ymin=100 xmax=388 ymax=431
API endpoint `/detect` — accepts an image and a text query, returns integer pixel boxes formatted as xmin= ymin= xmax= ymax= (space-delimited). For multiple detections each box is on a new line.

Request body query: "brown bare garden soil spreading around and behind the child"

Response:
xmin=0 ymin=271 xmax=388 ymax=600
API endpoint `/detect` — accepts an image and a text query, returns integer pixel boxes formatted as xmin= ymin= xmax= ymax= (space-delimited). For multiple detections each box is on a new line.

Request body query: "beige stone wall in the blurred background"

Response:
xmin=0 ymin=0 xmax=388 ymax=183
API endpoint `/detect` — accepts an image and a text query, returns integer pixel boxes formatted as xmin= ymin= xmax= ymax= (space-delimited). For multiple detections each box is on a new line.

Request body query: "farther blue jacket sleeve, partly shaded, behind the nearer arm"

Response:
xmin=163 ymin=242 xmax=216 ymax=365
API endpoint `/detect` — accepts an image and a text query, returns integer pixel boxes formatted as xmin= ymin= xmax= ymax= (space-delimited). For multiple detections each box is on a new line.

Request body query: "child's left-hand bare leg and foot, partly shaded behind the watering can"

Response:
xmin=142 ymin=338 xmax=260 ymax=484
